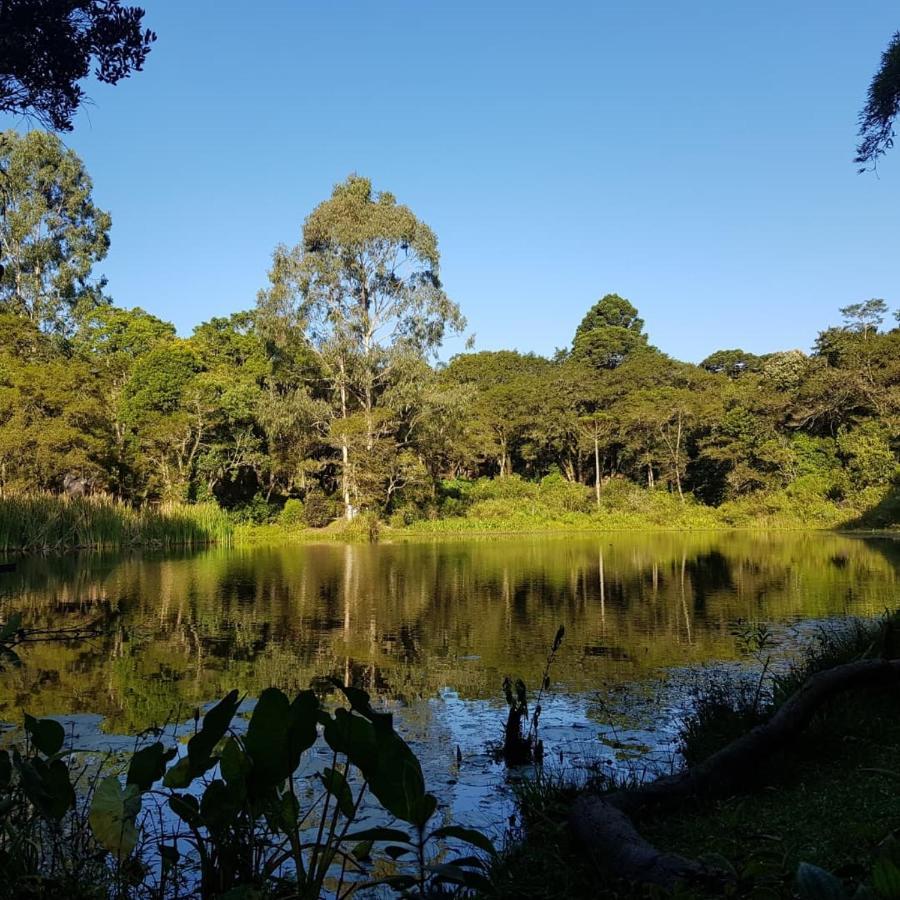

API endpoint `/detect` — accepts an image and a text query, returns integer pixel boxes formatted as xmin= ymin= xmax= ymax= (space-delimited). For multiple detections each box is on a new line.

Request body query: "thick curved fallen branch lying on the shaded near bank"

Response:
xmin=569 ymin=659 xmax=900 ymax=887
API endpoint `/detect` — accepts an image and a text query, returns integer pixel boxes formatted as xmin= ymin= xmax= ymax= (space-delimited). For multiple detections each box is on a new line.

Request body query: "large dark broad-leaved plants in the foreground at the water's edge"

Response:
xmin=0 ymin=684 xmax=496 ymax=898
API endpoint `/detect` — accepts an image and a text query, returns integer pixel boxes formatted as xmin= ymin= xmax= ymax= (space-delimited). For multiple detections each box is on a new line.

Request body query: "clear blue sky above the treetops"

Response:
xmin=0 ymin=0 xmax=900 ymax=361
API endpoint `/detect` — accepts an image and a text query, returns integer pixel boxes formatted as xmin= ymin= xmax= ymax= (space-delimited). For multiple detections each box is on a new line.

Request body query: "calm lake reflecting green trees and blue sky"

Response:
xmin=0 ymin=532 xmax=900 ymax=832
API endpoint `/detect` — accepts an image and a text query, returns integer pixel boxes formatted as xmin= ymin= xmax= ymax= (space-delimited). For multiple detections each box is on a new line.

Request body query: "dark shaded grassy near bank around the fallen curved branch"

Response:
xmin=496 ymin=627 xmax=900 ymax=898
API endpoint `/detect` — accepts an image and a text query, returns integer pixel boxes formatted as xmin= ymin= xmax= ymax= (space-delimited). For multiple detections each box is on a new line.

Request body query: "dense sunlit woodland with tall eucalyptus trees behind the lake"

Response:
xmin=0 ymin=131 xmax=900 ymax=525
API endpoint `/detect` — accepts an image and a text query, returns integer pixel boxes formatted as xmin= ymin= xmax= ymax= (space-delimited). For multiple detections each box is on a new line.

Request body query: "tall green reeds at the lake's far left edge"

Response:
xmin=0 ymin=494 xmax=231 ymax=553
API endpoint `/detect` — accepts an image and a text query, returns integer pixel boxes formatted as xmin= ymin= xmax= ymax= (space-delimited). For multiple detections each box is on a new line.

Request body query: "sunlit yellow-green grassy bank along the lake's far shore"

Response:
xmin=230 ymin=475 xmax=900 ymax=543
